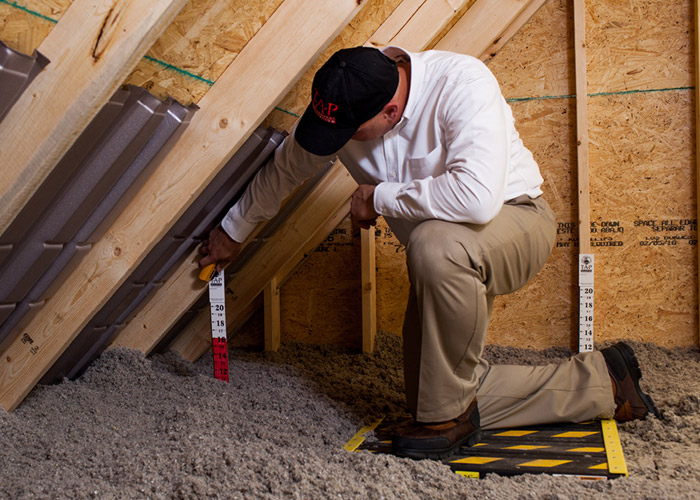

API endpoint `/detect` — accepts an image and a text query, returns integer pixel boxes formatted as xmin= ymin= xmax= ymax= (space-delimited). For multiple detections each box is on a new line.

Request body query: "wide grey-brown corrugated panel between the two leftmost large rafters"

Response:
xmin=0 ymin=86 xmax=196 ymax=350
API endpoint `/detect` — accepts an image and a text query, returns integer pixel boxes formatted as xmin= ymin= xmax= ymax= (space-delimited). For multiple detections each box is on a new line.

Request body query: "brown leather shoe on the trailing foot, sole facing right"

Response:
xmin=600 ymin=342 xmax=659 ymax=422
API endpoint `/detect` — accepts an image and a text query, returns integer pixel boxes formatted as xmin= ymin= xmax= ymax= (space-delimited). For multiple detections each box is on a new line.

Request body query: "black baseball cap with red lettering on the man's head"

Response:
xmin=295 ymin=47 xmax=399 ymax=156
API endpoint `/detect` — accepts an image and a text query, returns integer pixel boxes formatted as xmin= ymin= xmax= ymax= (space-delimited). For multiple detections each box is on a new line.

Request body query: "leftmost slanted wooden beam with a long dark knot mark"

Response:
xmin=0 ymin=0 xmax=187 ymax=234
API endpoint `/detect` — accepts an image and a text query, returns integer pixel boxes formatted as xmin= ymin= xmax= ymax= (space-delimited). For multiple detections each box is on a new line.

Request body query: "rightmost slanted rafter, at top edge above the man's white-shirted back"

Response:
xmin=435 ymin=0 xmax=530 ymax=57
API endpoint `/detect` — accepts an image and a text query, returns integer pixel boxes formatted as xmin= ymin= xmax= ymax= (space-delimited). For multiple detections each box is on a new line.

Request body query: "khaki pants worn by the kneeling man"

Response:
xmin=403 ymin=196 xmax=615 ymax=428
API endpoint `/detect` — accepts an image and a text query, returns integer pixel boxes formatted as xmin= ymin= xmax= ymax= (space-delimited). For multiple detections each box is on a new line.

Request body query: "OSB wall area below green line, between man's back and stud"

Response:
xmin=487 ymin=98 xmax=578 ymax=349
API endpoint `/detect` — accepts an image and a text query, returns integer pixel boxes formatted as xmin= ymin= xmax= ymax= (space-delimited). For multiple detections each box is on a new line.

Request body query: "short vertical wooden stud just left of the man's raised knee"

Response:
xmin=360 ymin=227 xmax=377 ymax=353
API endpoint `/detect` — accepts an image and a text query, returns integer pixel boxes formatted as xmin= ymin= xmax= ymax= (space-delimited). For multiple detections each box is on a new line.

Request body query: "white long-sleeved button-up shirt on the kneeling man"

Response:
xmin=222 ymin=47 xmax=543 ymax=243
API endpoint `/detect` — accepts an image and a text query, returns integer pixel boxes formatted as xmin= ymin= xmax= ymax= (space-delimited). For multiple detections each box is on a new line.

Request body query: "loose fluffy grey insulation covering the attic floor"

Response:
xmin=0 ymin=334 xmax=700 ymax=499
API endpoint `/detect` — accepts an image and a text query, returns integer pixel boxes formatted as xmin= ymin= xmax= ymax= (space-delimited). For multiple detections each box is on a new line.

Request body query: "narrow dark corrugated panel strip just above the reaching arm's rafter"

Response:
xmin=42 ymin=128 xmax=284 ymax=383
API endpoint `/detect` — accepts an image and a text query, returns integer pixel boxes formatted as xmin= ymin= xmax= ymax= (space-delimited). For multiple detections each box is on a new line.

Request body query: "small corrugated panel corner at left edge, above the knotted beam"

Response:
xmin=0 ymin=42 xmax=49 ymax=121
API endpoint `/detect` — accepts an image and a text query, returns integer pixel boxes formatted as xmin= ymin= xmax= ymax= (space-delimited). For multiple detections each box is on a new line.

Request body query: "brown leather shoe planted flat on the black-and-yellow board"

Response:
xmin=391 ymin=398 xmax=481 ymax=459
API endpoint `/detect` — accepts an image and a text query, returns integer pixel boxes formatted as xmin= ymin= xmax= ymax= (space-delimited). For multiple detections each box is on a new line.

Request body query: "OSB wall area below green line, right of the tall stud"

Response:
xmin=589 ymin=90 xmax=698 ymax=346
